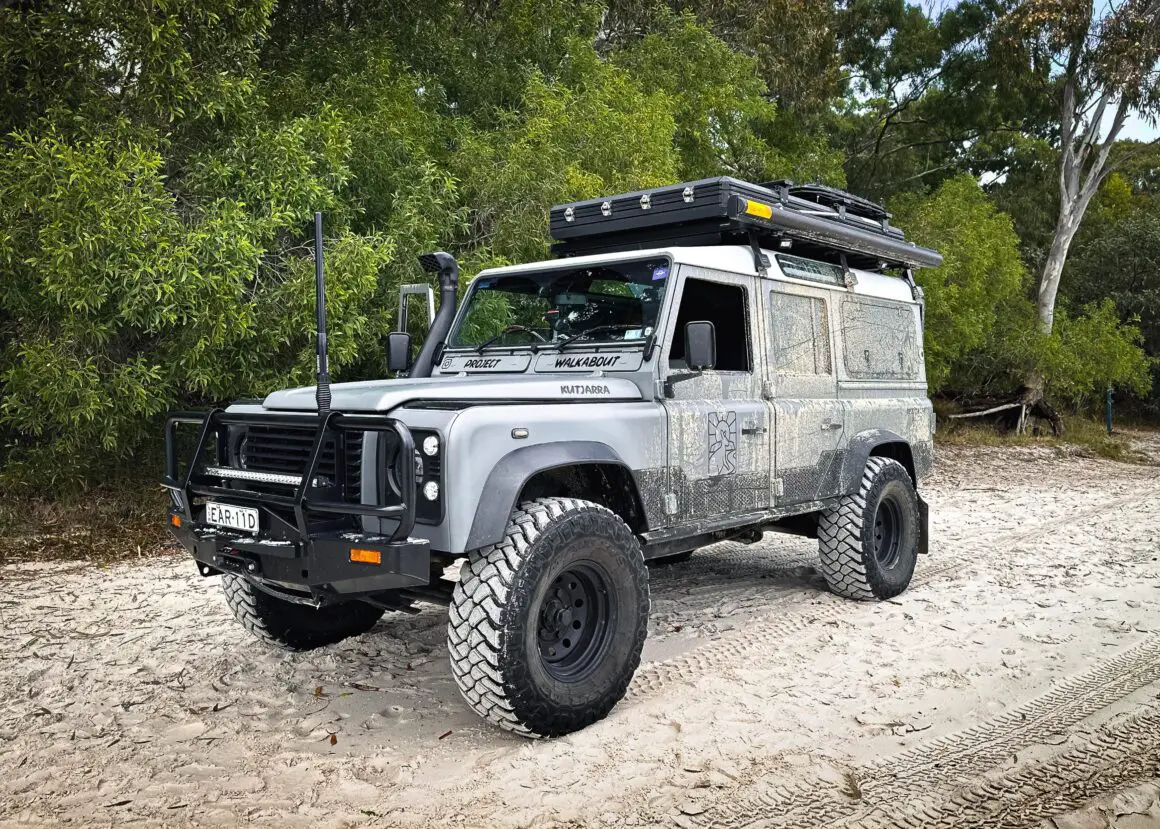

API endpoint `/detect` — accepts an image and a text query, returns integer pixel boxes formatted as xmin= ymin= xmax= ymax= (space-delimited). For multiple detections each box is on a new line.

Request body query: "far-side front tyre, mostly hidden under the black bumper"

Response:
xmin=222 ymin=574 xmax=383 ymax=650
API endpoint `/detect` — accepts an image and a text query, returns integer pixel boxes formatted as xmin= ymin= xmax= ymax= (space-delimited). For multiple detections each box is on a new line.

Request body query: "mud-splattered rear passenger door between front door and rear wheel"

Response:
xmin=763 ymin=283 xmax=844 ymax=507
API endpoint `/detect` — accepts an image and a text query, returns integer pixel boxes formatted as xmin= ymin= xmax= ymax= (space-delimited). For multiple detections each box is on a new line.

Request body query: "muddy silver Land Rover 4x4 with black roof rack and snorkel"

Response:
xmin=165 ymin=177 xmax=941 ymax=735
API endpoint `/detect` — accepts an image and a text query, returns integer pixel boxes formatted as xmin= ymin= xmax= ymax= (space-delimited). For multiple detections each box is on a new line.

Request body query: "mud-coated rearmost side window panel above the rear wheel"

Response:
xmin=841 ymin=298 xmax=922 ymax=380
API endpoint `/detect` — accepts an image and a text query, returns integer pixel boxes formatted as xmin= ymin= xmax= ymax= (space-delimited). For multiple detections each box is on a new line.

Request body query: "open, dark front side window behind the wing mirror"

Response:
xmin=668 ymin=279 xmax=753 ymax=371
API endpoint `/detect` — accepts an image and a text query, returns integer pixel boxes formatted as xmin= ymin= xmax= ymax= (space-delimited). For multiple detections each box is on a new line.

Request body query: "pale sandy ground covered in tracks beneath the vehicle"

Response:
xmin=0 ymin=437 xmax=1160 ymax=829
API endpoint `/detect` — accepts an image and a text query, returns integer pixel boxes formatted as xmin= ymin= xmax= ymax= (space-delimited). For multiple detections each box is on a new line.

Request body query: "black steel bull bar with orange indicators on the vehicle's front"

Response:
xmin=162 ymin=408 xmax=430 ymax=605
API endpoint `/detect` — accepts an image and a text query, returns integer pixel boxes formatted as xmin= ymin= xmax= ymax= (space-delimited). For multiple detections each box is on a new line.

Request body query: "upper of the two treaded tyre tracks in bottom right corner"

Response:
xmin=686 ymin=635 xmax=1160 ymax=829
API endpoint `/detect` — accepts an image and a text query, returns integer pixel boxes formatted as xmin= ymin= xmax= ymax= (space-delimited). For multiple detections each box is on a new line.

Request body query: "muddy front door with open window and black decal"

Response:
xmin=662 ymin=266 xmax=771 ymax=524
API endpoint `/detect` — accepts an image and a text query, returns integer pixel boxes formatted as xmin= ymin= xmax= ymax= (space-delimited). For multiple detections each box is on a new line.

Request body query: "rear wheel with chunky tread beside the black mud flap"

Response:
xmin=818 ymin=458 xmax=921 ymax=599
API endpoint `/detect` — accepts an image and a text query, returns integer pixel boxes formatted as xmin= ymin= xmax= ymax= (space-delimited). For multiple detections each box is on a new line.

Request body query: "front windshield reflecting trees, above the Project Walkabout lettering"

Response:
xmin=448 ymin=259 xmax=669 ymax=348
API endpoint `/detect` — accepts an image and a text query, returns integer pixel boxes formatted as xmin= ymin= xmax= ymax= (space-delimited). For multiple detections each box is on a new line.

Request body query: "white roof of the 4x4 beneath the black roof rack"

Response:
xmin=478 ymin=245 xmax=914 ymax=303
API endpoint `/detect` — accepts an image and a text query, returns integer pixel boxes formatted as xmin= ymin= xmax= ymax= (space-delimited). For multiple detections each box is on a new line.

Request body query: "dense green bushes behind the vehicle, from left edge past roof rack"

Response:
xmin=0 ymin=0 xmax=841 ymax=486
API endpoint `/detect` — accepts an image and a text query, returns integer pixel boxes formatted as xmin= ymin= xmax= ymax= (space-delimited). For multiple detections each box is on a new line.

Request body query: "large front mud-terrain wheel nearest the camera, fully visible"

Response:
xmin=447 ymin=497 xmax=648 ymax=736
